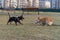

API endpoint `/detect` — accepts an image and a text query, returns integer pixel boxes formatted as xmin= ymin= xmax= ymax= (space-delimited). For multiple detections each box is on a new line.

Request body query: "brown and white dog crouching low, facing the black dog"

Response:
xmin=36 ymin=17 xmax=53 ymax=25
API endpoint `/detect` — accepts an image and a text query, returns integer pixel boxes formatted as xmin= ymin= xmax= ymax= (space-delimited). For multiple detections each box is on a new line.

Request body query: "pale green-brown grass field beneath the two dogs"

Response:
xmin=0 ymin=12 xmax=60 ymax=40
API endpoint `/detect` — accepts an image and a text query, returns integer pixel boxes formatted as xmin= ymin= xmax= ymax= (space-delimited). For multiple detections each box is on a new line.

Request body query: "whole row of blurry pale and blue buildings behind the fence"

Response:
xmin=0 ymin=0 xmax=60 ymax=9
